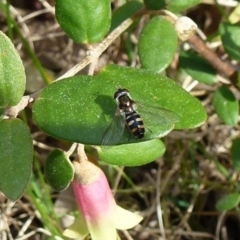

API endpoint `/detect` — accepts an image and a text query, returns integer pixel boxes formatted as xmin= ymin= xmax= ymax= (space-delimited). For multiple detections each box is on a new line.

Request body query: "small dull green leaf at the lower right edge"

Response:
xmin=216 ymin=193 xmax=240 ymax=211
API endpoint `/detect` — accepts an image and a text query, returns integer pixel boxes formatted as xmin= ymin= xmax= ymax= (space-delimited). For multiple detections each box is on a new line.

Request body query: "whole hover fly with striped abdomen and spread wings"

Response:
xmin=102 ymin=88 xmax=179 ymax=146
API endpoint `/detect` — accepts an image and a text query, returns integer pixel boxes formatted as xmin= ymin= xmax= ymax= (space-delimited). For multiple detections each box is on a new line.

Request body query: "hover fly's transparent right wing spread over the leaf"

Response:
xmin=135 ymin=102 xmax=180 ymax=138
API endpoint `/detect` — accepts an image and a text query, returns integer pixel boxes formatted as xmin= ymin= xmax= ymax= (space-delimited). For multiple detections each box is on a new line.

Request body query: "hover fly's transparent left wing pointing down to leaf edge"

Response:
xmin=102 ymin=109 xmax=125 ymax=146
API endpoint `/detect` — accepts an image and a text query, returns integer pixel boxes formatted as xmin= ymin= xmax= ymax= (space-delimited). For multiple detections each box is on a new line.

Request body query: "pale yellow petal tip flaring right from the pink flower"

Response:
xmin=114 ymin=206 xmax=143 ymax=230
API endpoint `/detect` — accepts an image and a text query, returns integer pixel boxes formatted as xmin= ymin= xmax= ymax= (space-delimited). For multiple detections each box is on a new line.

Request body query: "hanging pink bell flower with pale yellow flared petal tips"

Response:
xmin=64 ymin=161 xmax=142 ymax=240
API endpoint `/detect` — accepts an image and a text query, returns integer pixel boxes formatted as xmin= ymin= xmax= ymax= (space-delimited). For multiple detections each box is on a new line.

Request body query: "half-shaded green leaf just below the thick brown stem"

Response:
xmin=179 ymin=51 xmax=217 ymax=84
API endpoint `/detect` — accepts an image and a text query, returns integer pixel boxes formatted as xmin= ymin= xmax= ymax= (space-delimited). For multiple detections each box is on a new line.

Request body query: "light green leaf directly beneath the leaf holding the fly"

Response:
xmin=98 ymin=139 xmax=165 ymax=166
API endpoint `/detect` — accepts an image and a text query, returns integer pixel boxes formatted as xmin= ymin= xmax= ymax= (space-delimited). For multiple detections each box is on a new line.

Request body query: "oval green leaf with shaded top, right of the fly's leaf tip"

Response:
xmin=213 ymin=86 xmax=239 ymax=126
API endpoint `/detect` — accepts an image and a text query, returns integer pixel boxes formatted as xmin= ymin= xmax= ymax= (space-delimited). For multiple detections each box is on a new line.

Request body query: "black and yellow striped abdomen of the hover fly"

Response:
xmin=125 ymin=111 xmax=145 ymax=138
